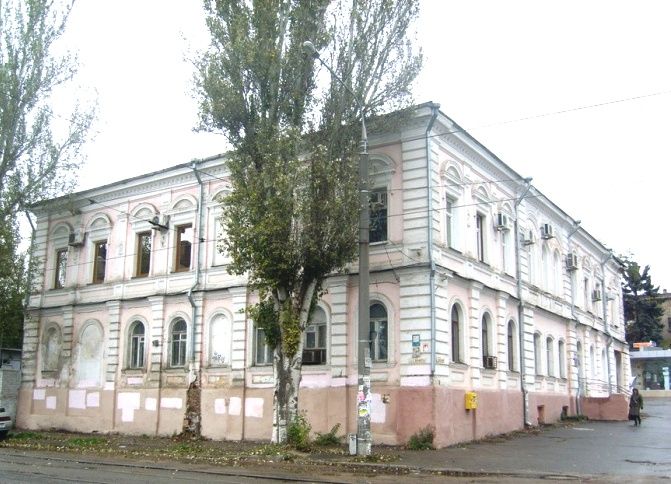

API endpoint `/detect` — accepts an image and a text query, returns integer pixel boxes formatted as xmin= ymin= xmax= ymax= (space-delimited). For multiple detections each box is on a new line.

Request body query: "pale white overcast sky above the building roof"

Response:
xmin=59 ymin=0 xmax=671 ymax=289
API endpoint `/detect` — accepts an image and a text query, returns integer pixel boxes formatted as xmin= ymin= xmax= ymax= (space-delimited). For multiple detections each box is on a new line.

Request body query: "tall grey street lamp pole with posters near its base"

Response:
xmin=303 ymin=40 xmax=373 ymax=456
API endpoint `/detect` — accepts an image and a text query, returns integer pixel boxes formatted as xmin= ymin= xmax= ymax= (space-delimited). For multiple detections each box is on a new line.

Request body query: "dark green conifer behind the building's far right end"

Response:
xmin=622 ymin=257 xmax=664 ymax=345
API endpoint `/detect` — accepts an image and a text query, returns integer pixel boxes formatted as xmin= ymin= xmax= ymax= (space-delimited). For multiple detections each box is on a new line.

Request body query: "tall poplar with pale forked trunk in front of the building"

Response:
xmin=197 ymin=0 xmax=421 ymax=442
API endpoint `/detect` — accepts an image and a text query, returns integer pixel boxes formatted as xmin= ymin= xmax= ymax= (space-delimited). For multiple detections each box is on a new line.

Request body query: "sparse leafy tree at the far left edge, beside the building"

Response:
xmin=0 ymin=0 xmax=93 ymax=345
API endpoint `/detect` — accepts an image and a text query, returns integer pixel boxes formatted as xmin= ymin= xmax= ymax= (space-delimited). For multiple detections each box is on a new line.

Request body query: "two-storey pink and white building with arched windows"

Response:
xmin=17 ymin=103 xmax=631 ymax=446
